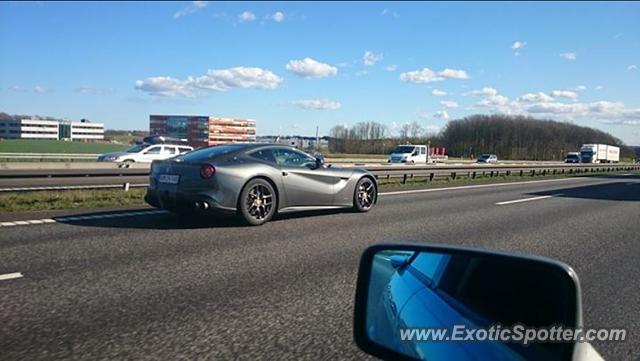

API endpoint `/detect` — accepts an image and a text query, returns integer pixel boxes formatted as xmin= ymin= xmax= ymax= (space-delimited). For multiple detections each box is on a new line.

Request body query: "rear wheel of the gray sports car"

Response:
xmin=239 ymin=178 xmax=278 ymax=226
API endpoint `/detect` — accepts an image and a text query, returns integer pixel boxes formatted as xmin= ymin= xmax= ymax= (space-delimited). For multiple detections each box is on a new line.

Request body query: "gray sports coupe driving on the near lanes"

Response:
xmin=145 ymin=143 xmax=378 ymax=225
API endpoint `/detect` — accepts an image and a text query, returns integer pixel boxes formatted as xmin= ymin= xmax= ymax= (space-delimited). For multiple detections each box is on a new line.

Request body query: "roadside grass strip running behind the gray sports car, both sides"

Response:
xmin=0 ymin=171 xmax=640 ymax=213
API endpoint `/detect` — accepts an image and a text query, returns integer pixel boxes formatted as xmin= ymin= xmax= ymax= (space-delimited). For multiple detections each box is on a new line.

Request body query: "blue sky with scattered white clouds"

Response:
xmin=0 ymin=2 xmax=640 ymax=145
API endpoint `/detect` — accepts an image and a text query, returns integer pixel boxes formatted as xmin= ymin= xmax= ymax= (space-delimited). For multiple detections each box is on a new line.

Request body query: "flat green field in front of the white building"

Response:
xmin=0 ymin=139 xmax=131 ymax=154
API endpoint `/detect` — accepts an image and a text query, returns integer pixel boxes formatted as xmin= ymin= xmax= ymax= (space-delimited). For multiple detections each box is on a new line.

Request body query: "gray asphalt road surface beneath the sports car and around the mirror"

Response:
xmin=0 ymin=175 xmax=640 ymax=360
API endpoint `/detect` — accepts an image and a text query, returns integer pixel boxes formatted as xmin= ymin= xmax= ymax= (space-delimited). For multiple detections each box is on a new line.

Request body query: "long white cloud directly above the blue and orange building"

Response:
xmin=135 ymin=67 xmax=282 ymax=97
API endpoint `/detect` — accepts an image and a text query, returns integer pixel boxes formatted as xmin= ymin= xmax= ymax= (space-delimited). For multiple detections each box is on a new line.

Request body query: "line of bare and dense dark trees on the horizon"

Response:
xmin=329 ymin=114 xmax=635 ymax=160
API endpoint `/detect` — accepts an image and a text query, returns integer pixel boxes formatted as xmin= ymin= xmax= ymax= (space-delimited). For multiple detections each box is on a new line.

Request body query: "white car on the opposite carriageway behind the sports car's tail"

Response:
xmin=98 ymin=143 xmax=193 ymax=164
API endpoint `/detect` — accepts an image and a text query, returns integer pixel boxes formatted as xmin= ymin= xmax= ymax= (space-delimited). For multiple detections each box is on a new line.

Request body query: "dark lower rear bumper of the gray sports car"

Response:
xmin=144 ymin=188 xmax=236 ymax=213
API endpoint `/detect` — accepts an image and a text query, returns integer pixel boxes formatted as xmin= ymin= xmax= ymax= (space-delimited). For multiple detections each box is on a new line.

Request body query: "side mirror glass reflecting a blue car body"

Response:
xmin=363 ymin=249 xmax=578 ymax=361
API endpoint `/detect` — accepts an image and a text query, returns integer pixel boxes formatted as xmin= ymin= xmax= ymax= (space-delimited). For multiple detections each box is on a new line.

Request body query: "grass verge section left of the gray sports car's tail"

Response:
xmin=0 ymin=188 xmax=146 ymax=212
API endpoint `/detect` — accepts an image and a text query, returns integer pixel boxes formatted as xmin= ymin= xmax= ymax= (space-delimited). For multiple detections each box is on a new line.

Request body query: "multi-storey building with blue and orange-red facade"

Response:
xmin=149 ymin=115 xmax=256 ymax=147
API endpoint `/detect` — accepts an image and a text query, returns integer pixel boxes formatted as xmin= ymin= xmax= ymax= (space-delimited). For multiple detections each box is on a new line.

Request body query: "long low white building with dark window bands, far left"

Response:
xmin=0 ymin=118 xmax=104 ymax=141
